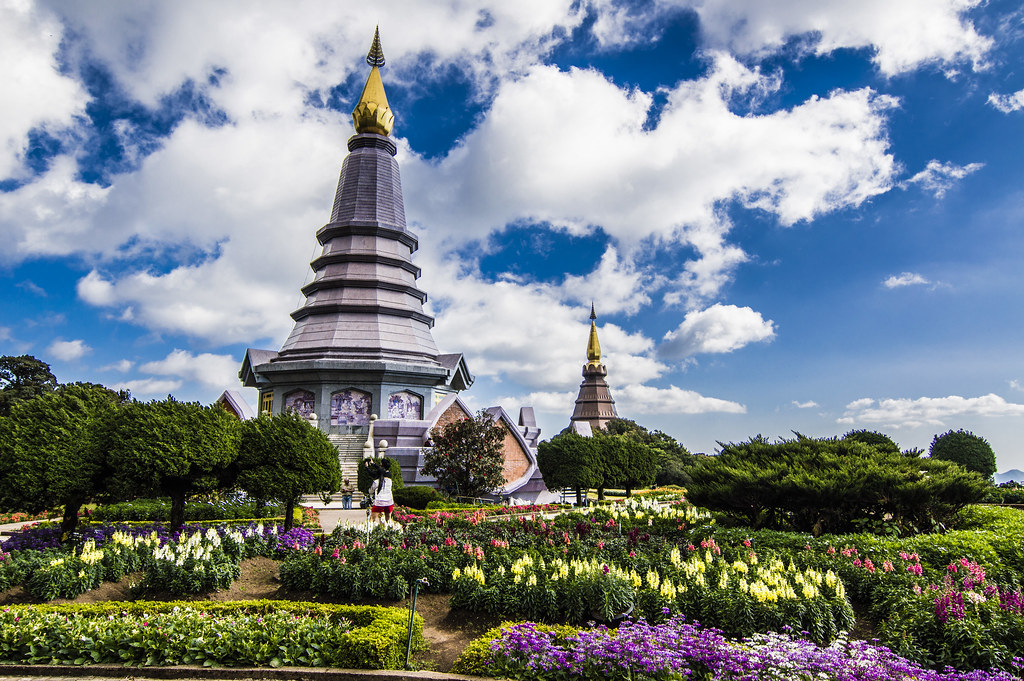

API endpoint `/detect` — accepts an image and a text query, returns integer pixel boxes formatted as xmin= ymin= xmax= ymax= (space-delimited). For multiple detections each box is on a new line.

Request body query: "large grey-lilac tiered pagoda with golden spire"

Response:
xmin=239 ymin=27 xmax=544 ymax=499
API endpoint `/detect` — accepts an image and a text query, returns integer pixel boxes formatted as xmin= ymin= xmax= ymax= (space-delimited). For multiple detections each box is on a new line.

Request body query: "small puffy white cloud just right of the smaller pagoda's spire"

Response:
xmin=657 ymin=303 xmax=775 ymax=359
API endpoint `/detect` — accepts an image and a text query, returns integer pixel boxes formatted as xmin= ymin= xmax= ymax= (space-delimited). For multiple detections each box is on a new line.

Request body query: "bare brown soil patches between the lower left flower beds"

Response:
xmin=0 ymin=558 xmax=501 ymax=672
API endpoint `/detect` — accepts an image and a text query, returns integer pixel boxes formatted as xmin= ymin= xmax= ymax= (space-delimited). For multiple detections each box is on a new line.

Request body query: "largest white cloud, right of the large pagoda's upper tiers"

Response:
xmin=401 ymin=53 xmax=896 ymax=305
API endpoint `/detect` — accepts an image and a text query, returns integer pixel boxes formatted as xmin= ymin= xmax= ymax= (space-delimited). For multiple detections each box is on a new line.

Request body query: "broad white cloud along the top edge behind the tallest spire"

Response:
xmin=48 ymin=0 xmax=584 ymax=116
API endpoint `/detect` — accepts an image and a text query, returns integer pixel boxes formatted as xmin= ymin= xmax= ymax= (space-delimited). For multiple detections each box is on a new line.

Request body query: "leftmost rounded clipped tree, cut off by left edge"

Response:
xmin=0 ymin=383 xmax=127 ymax=535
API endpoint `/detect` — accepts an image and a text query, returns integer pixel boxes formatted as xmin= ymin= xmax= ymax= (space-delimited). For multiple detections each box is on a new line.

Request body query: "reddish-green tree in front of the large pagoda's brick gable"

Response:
xmin=420 ymin=411 xmax=505 ymax=497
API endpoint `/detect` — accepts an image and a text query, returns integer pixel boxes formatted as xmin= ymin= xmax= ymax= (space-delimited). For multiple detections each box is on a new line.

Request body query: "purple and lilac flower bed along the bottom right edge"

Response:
xmin=452 ymin=618 xmax=1024 ymax=681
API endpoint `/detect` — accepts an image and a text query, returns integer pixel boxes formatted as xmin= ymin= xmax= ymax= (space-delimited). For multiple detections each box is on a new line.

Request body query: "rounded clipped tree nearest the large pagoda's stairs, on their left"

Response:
xmin=234 ymin=412 xmax=341 ymax=531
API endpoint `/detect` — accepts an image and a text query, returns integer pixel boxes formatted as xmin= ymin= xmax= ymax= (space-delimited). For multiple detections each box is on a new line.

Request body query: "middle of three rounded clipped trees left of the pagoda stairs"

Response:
xmin=96 ymin=396 xmax=239 ymax=528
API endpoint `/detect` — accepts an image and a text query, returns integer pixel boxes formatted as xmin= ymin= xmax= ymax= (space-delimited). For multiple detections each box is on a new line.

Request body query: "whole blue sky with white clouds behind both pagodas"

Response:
xmin=0 ymin=0 xmax=1024 ymax=470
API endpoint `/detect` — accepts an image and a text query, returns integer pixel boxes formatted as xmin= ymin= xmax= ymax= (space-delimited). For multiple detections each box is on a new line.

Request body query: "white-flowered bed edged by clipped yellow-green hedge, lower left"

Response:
xmin=0 ymin=601 xmax=423 ymax=669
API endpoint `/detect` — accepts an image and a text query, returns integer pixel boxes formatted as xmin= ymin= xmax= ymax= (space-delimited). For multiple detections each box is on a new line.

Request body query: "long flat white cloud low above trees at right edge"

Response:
xmin=839 ymin=393 xmax=1024 ymax=428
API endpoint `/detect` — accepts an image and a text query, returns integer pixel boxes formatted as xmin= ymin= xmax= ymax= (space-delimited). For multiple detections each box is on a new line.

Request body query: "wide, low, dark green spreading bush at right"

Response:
xmin=690 ymin=436 xmax=988 ymax=536
